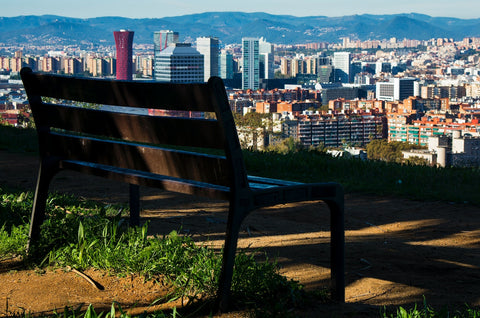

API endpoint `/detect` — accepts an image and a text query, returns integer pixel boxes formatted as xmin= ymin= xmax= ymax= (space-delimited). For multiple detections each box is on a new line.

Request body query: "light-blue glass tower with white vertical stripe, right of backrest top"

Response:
xmin=242 ymin=38 xmax=260 ymax=90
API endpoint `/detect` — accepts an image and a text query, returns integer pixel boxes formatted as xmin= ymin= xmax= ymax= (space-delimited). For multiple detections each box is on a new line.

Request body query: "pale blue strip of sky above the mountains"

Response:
xmin=0 ymin=0 xmax=480 ymax=19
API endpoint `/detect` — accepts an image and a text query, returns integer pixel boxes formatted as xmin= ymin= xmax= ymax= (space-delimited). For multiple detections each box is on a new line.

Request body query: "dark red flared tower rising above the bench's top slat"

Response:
xmin=113 ymin=30 xmax=134 ymax=80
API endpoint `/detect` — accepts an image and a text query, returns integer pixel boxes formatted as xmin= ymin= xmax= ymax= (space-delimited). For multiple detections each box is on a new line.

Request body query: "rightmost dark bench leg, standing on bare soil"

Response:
xmin=326 ymin=196 xmax=345 ymax=302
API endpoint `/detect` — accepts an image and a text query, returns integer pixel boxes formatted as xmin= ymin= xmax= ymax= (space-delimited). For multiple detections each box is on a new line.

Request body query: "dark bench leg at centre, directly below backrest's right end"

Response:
xmin=215 ymin=207 xmax=243 ymax=312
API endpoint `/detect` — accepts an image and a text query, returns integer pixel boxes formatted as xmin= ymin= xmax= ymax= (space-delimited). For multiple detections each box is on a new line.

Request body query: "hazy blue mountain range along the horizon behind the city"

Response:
xmin=0 ymin=12 xmax=480 ymax=45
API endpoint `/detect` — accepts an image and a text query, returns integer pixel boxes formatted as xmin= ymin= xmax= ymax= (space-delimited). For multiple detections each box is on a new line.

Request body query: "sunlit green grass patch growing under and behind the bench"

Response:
xmin=0 ymin=188 xmax=306 ymax=316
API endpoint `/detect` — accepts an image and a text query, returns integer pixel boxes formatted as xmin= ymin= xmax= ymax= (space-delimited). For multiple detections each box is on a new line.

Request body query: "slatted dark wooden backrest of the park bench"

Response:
xmin=21 ymin=68 xmax=248 ymax=198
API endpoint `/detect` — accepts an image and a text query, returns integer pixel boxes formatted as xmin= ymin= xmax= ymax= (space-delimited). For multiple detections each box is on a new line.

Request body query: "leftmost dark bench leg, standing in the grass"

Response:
xmin=27 ymin=162 xmax=58 ymax=254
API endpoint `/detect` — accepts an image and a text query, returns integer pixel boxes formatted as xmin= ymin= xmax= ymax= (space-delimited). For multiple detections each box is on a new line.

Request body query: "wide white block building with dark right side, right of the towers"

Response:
xmin=376 ymin=77 xmax=419 ymax=101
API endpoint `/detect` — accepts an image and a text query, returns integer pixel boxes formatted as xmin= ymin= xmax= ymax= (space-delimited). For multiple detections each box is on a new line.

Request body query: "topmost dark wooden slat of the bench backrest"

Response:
xmin=22 ymin=69 xmax=220 ymax=112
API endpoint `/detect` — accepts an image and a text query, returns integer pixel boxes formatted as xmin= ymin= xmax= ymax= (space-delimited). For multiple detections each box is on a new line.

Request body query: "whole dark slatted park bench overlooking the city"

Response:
xmin=21 ymin=68 xmax=345 ymax=311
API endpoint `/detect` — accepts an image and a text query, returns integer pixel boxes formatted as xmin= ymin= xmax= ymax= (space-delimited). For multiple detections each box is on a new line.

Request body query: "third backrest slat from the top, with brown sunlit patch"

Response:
xmin=46 ymin=133 xmax=230 ymax=186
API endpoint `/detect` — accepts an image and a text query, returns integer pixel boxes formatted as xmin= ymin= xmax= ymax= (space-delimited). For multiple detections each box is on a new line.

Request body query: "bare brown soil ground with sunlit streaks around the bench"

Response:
xmin=0 ymin=151 xmax=480 ymax=317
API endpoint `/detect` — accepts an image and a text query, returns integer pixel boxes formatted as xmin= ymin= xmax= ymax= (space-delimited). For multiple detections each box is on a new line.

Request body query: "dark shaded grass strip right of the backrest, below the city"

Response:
xmin=244 ymin=150 xmax=480 ymax=205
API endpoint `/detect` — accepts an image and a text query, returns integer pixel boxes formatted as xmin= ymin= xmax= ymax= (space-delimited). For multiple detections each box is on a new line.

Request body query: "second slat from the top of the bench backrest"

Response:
xmin=34 ymin=104 xmax=225 ymax=149
